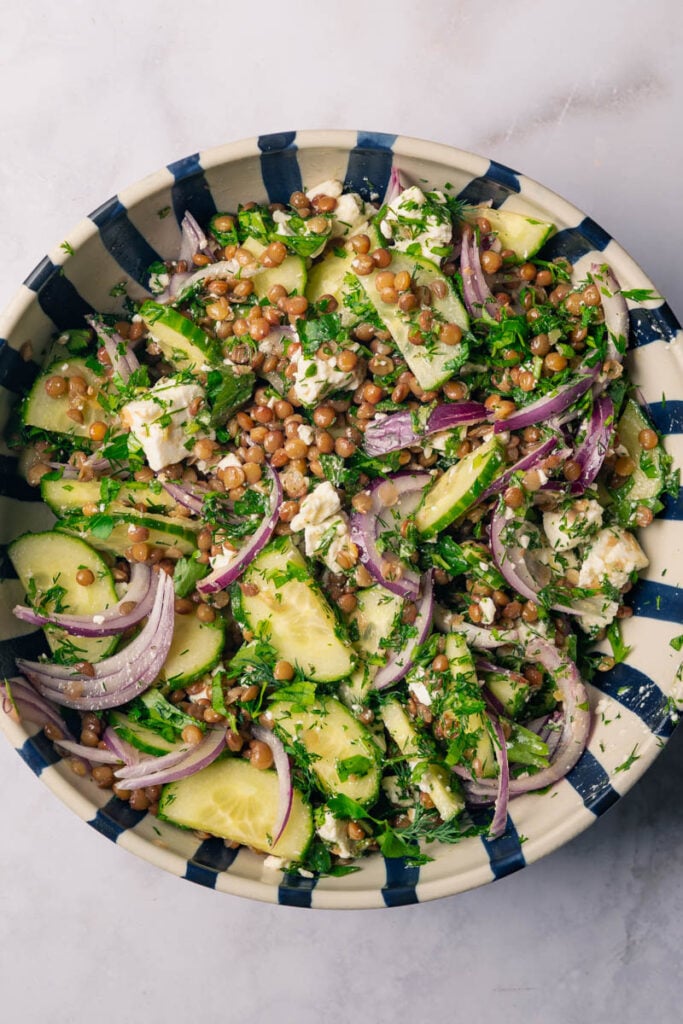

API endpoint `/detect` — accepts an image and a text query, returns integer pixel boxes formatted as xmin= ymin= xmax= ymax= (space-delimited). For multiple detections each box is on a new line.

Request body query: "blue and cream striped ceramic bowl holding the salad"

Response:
xmin=0 ymin=131 xmax=683 ymax=908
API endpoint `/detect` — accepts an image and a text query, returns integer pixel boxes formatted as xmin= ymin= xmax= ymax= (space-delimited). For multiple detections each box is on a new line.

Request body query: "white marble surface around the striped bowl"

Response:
xmin=0 ymin=0 xmax=683 ymax=1024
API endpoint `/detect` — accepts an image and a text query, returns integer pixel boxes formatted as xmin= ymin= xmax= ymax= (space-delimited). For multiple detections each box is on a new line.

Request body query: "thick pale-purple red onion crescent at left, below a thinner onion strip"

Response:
xmin=16 ymin=572 xmax=175 ymax=711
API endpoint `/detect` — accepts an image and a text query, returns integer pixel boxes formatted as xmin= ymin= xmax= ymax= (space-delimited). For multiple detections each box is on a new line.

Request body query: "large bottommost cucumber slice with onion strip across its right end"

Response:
xmin=159 ymin=758 xmax=313 ymax=860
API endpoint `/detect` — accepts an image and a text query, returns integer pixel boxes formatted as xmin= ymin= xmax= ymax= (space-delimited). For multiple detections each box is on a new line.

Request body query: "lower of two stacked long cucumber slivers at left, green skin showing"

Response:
xmin=54 ymin=512 xmax=197 ymax=556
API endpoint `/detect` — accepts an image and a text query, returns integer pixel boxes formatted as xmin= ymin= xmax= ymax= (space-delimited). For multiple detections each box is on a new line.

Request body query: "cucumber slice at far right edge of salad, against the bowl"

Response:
xmin=611 ymin=398 xmax=666 ymax=526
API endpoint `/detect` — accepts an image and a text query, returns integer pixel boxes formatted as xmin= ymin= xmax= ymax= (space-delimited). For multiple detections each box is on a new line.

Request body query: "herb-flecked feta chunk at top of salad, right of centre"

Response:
xmin=380 ymin=185 xmax=453 ymax=261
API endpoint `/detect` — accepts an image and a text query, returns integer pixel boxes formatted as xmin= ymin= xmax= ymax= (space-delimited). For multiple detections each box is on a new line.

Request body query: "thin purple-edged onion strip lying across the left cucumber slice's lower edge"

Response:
xmin=12 ymin=562 xmax=155 ymax=637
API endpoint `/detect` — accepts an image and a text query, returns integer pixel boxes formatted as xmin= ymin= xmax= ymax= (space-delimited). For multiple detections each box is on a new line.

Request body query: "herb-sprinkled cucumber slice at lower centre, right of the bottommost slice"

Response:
xmin=268 ymin=694 xmax=382 ymax=805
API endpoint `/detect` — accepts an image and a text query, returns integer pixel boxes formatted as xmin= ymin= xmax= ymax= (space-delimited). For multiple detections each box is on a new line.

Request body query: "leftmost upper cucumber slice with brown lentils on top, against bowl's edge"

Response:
xmin=22 ymin=358 xmax=109 ymax=437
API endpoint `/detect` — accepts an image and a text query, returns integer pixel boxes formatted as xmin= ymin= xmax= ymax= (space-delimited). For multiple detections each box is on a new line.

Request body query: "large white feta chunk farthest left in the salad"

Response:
xmin=121 ymin=378 xmax=210 ymax=472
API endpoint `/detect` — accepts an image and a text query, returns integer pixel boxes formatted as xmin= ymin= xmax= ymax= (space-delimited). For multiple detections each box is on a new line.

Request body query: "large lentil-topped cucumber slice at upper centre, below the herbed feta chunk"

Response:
xmin=358 ymin=251 xmax=469 ymax=391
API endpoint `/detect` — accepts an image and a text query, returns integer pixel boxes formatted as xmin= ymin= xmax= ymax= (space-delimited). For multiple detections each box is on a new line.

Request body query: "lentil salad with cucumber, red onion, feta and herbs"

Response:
xmin=2 ymin=170 xmax=677 ymax=874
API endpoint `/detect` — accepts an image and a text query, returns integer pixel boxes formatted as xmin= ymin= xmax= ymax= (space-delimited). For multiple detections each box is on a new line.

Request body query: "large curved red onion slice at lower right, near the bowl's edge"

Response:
xmin=458 ymin=636 xmax=591 ymax=800
